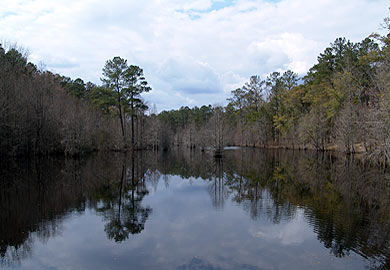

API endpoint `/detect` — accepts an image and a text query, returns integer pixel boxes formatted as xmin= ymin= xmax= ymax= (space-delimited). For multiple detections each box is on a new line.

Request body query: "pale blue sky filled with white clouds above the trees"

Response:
xmin=0 ymin=0 xmax=390 ymax=111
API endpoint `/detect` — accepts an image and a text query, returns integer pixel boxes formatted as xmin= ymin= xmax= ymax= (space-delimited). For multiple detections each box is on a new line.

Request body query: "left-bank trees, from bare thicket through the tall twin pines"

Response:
xmin=0 ymin=44 xmax=155 ymax=156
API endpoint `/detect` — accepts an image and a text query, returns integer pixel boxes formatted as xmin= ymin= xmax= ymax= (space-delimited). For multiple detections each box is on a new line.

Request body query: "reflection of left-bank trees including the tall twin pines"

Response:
xmin=0 ymin=154 xmax=151 ymax=267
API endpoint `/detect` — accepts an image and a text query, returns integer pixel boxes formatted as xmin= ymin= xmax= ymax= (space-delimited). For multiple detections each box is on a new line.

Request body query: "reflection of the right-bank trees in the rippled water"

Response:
xmin=151 ymin=149 xmax=390 ymax=269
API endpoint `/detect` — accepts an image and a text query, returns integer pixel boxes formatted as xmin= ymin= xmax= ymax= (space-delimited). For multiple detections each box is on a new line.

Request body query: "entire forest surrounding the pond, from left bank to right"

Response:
xmin=0 ymin=18 xmax=390 ymax=166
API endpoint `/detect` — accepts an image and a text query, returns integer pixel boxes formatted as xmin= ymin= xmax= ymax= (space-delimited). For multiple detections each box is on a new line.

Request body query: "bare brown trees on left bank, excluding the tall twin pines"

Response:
xmin=0 ymin=46 xmax=125 ymax=156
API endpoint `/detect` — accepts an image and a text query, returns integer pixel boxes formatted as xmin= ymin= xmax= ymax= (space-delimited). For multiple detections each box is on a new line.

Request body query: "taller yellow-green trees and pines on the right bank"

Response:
xmin=209 ymin=28 xmax=390 ymax=153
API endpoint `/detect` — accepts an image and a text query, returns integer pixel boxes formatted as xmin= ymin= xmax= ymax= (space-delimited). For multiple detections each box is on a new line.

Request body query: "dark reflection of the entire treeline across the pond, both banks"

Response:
xmin=0 ymin=149 xmax=390 ymax=269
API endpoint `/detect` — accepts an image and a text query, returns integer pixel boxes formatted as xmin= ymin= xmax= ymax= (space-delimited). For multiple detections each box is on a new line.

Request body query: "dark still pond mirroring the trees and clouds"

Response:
xmin=0 ymin=149 xmax=390 ymax=270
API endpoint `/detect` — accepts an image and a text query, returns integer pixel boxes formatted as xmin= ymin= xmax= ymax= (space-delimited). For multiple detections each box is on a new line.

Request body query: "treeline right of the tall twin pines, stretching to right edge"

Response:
xmin=158 ymin=19 xmax=390 ymax=164
